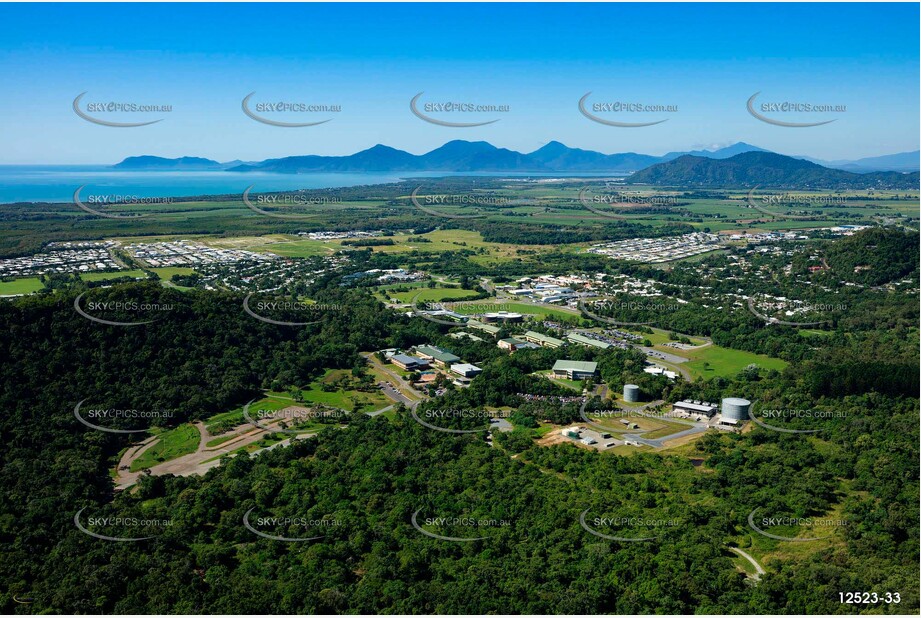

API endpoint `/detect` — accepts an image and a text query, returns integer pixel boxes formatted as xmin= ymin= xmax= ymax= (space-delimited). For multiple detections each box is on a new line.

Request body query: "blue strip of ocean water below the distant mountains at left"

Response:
xmin=0 ymin=165 xmax=624 ymax=204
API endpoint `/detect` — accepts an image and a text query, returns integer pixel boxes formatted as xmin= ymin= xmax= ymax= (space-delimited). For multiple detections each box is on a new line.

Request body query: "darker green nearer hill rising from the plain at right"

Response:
xmin=626 ymin=151 xmax=919 ymax=189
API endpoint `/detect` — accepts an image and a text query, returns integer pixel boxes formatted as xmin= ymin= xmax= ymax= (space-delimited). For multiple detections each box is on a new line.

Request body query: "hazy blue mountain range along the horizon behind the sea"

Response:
xmin=115 ymin=140 xmax=919 ymax=174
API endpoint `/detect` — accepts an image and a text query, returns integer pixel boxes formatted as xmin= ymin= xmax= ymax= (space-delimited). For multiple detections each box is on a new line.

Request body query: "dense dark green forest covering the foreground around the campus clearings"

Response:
xmin=0 ymin=282 xmax=918 ymax=614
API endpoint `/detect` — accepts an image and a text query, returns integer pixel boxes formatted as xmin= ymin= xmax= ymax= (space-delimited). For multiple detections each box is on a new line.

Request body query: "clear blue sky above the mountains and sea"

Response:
xmin=0 ymin=3 xmax=921 ymax=164
